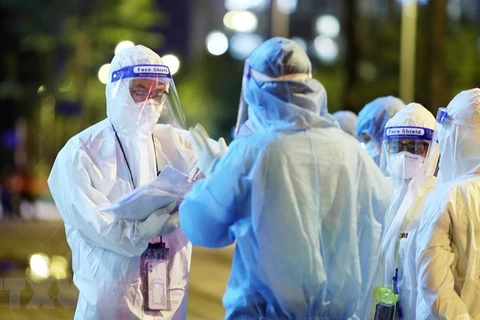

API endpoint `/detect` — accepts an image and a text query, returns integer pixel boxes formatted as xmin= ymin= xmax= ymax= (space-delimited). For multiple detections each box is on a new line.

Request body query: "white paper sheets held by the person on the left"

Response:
xmin=97 ymin=166 xmax=192 ymax=220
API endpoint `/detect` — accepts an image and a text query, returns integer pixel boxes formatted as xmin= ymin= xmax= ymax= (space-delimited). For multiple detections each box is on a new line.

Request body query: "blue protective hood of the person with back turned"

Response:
xmin=237 ymin=38 xmax=338 ymax=132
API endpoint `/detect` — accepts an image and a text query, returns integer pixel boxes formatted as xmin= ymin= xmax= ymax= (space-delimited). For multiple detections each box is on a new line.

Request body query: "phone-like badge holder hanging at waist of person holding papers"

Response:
xmin=140 ymin=237 xmax=170 ymax=311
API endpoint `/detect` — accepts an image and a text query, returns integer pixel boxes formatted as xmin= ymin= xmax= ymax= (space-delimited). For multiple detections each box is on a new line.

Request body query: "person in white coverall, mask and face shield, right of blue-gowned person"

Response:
xmin=378 ymin=103 xmax=439 ymax=319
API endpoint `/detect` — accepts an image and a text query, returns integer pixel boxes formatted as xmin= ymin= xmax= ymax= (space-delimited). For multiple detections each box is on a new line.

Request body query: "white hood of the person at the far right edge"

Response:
xmin=438 ymin=88 xmax=480 ymax=182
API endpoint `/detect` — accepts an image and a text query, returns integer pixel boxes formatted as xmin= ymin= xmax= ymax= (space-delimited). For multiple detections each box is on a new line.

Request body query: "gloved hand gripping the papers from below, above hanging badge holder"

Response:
xmin=137 ymin=201 xmax=178 ymax=240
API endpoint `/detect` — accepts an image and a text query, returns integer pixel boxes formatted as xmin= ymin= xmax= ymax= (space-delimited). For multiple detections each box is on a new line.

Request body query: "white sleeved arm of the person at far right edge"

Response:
xmin=416 ymin=192 xmax=470 ymax=319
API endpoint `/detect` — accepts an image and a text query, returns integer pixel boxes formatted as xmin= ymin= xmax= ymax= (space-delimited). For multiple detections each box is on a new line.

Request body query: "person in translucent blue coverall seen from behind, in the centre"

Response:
xmin=180 ymin=38 xmax=391 ymax=319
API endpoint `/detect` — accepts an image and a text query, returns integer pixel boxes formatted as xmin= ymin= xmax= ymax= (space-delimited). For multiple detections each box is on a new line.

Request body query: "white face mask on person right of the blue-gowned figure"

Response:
xmin=387 ymin=151 xmax=425 ymax=180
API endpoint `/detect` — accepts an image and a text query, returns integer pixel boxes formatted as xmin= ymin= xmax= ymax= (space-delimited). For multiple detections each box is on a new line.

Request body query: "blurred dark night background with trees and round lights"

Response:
xmin=0 ymin=0 xmax=480 ymax=319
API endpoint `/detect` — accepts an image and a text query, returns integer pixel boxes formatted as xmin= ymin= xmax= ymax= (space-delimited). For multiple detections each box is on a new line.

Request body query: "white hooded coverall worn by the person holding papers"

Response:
xmin=48 ymin=46 xmax=197 ymax=320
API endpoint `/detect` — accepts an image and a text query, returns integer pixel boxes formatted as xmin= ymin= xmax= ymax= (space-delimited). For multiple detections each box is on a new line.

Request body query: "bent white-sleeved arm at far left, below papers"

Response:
xmin=48 ymin=145 xmax=158 ymax=256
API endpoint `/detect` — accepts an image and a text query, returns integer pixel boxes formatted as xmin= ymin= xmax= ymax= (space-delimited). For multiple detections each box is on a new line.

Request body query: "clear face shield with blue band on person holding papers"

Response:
xmin=111 ymin=64 xmax=185 ymax=128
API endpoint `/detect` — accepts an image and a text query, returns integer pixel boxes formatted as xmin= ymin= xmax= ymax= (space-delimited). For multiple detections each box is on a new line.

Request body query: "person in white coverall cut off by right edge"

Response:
xmin=417 ymin=88 xmax=480 ymax=319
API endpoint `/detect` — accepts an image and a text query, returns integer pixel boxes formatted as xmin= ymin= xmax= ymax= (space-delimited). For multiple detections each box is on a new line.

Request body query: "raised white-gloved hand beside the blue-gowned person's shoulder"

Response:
xmin=189 ymin=124 xmax=228 ymax=176
